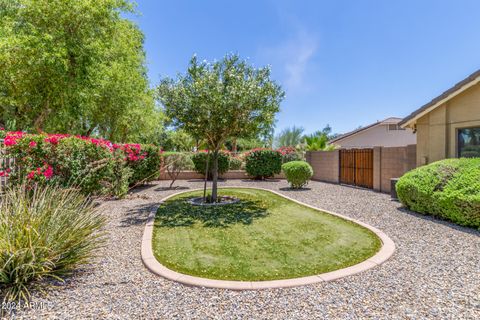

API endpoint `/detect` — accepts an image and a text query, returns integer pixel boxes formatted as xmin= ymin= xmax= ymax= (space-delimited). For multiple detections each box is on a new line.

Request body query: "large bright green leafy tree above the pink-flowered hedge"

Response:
xmin=0 ymin=0 xmax=162 ymax=142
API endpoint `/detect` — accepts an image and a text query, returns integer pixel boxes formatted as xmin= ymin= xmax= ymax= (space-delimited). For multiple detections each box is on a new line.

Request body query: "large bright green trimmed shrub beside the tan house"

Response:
xmin=396 ymin=158 xmax=480 ymax=228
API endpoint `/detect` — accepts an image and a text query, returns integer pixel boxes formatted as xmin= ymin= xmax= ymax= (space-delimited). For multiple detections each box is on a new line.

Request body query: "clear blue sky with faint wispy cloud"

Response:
xmin=127 ymin=0 xmax=480 ymax=133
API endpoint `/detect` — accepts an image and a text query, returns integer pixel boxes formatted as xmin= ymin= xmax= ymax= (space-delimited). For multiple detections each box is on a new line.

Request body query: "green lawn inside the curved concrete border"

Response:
xmin=152 ymin=188 xmax=381 ymax=281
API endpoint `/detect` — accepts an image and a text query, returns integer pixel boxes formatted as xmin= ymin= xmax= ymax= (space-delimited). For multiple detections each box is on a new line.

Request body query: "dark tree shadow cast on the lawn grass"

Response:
xmin=155 ymin=198 xmax=268 ymax=228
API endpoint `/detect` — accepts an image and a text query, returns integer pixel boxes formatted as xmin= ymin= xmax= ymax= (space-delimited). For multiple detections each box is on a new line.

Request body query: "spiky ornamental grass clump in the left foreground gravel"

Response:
xmin=0 ymin=184 xmax=105 ymax=301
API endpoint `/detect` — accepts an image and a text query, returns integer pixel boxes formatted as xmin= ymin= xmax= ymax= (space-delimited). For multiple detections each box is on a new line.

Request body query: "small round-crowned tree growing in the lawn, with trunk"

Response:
xmin=158 ymin=55 xmax=285 ymax=202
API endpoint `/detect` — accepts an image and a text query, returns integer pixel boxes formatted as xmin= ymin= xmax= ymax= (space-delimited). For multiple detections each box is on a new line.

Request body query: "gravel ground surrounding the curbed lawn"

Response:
xmin=7 ymin=180 xmax=480 ymax=319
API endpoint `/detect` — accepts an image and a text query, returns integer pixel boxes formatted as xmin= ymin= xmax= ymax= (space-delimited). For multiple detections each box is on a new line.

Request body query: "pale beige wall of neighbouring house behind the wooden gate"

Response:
xmin=334 ymin=124 xmax=416 ymax=148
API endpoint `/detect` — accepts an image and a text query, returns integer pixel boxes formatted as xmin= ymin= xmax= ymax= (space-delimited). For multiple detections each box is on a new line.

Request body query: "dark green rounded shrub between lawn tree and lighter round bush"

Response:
xmin=245 ymin=149 xmax=282 ymax=180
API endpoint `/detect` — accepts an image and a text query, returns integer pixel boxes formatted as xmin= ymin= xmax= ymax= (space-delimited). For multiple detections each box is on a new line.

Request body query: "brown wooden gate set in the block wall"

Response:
xmin=340 ymin=149 xmax=373 ymax=189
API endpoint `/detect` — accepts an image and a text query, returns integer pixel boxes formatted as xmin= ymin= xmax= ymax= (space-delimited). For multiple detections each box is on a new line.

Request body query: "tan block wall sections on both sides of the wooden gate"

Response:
xmin=306 ymin=145 xmax=416 ymax=193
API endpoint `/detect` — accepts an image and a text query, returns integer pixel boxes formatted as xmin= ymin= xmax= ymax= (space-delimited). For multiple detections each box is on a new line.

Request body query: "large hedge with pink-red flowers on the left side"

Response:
xmin=0 ymin=132 xmax=160 ymax=196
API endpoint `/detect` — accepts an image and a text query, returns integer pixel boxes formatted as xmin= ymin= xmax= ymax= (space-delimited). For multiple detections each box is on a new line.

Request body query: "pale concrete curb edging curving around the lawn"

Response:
xmin=141 ymin=186 xmax=395 ymax=290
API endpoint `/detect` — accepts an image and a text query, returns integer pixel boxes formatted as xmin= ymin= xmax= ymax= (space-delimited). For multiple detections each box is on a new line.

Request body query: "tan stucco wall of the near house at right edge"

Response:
xmin=417 ymin=84 xmax=480 ymax=166
